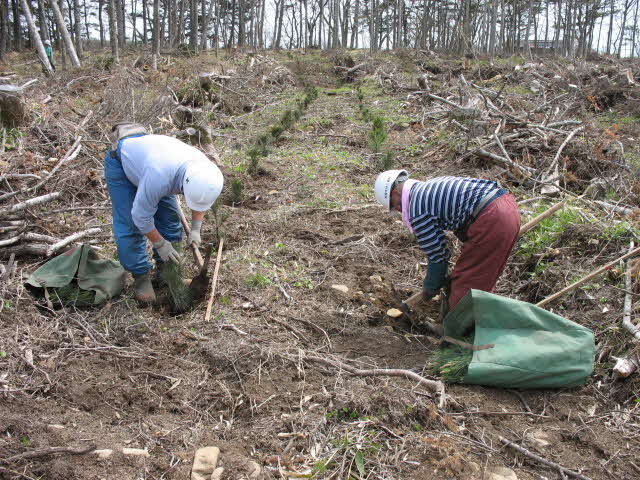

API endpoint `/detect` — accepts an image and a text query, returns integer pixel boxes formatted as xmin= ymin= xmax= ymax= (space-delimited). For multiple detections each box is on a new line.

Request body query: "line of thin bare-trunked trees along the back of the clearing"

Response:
xmin=0 ymin=0 xmax=640 ymax=65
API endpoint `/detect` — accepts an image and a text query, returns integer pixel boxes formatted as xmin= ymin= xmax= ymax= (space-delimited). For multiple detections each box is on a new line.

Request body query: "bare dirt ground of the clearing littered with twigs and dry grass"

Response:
xmin=0 ymin=52 xmax=640 ymax=480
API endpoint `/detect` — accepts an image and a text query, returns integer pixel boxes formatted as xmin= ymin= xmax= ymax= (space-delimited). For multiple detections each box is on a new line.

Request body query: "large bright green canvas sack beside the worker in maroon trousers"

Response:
xmin=444 ymin=290 xmax=595 ymax=388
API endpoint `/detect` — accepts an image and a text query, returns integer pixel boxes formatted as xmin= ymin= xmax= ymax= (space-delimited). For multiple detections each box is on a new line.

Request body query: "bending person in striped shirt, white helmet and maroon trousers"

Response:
xmin=375 ymin=170 xmax=520 ymax=308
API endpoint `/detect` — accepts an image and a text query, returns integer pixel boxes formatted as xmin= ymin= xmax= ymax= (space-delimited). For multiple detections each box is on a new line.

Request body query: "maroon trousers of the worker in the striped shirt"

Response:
xmin=449 ymin=193 xmax=520 ymax=309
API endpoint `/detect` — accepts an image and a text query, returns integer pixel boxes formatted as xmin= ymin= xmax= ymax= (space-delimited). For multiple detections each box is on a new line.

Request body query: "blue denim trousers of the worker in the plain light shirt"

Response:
xmin=104 ymin=151 xmax=182 ymax=275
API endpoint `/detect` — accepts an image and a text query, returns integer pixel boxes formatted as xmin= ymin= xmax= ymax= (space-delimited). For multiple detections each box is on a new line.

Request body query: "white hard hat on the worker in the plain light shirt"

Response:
xmin=182 ymin=160 xmax=224 ymax=212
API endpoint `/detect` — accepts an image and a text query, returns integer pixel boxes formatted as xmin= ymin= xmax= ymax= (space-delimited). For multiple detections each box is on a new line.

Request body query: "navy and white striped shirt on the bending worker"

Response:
xmin=409 ymin=177 xmax=500 ymax=263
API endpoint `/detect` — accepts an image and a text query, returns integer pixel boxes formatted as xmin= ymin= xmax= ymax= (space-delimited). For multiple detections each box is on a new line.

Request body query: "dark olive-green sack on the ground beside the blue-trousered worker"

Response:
xmin=26 ymin=244 xmax=125 ymax=305
